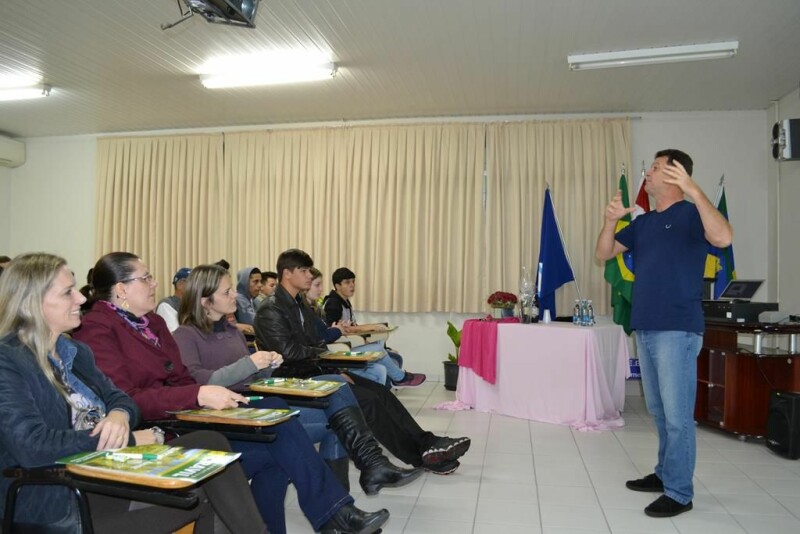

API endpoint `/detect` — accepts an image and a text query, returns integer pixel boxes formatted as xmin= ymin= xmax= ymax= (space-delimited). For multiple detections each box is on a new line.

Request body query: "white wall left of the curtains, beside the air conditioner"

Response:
xmin=5 ymin=136 xmax=96 ymax=280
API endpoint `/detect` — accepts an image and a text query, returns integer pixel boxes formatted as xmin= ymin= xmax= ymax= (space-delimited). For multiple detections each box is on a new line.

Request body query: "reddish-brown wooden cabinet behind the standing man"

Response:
xmin=694 ymin=324 xmax=800 ymax=436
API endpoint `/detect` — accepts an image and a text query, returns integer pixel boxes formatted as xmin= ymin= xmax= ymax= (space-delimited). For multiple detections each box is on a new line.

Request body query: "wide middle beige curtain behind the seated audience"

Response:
xmin=225 ymin=124 xmax=484 ymax=311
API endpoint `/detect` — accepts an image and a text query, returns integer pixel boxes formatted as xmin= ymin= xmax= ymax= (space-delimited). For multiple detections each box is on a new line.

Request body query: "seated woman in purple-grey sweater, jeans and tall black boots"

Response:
xmin=173 ymin=265 xmax=422 ymax=495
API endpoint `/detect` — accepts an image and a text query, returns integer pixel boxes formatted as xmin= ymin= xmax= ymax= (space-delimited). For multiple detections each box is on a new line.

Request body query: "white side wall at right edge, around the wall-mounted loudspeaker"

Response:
xmin=769 ymin=90 xmax=800 ymax=315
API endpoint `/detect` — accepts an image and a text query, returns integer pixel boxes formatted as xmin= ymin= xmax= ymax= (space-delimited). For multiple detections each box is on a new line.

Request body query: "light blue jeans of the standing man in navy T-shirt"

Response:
xmin=636 ymin=330 xmax=703 ymax=504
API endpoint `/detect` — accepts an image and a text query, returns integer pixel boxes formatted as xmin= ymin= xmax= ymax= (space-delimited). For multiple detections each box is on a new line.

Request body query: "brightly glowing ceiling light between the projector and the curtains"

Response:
xmin=198 ymin=52 xmax=337 ymax=89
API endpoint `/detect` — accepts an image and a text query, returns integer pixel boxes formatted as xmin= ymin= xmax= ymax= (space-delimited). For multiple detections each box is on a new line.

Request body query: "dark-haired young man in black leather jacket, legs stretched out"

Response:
xmin=255 ymin=249 xmax=470 ymax=474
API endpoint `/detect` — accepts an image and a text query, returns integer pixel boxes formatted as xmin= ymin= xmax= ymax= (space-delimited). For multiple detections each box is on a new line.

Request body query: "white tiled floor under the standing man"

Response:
xmin=286 ymin=382 xmax=800 ymax=534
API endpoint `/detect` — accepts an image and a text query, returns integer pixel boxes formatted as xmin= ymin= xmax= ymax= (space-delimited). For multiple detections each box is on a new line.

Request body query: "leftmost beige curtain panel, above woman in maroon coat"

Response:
xmin=95 ymin=135 xmax=229 ymax=296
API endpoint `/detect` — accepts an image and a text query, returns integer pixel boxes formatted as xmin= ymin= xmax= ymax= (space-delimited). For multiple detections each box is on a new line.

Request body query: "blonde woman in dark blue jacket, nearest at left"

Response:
xmin=0 ymin=253 xmax=265 ymax=534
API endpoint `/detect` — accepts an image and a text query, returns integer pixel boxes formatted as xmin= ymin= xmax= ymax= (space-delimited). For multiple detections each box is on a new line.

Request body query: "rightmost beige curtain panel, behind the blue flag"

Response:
xmin=484 ymin=119 xmax=631 ymax=315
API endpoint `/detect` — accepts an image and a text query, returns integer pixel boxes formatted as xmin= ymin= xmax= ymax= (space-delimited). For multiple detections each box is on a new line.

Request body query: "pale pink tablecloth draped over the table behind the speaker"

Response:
xmin=456 ymin=323 xmax=629 ymax=430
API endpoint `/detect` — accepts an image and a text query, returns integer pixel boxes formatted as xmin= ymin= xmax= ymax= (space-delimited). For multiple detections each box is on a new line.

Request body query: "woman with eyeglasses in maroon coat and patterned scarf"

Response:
xmin=74 ymin=252 xmax=389 ymax=534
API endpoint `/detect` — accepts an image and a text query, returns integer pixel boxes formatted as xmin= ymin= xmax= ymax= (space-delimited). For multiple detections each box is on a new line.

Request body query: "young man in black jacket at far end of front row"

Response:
xmin=322 ymin=267 xmax=426 ymax=387
